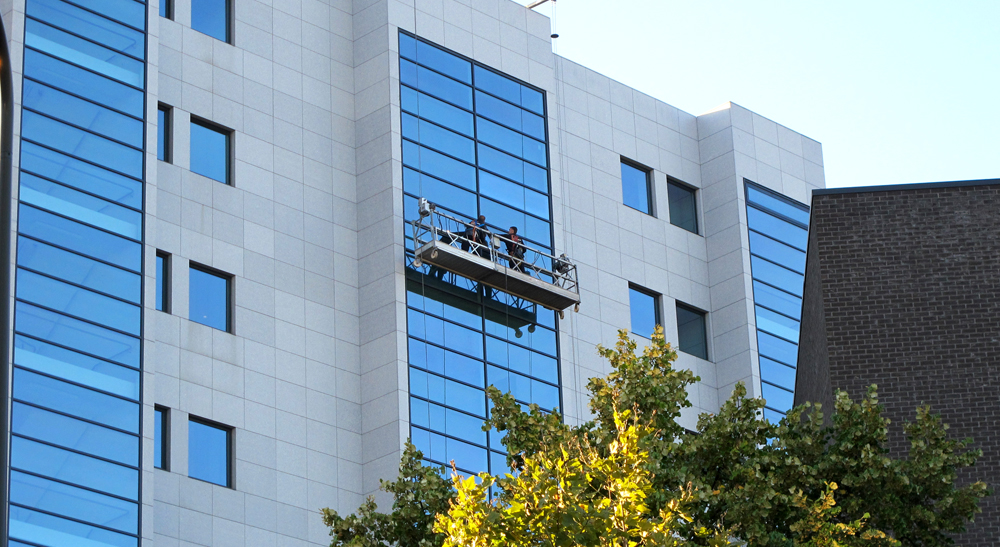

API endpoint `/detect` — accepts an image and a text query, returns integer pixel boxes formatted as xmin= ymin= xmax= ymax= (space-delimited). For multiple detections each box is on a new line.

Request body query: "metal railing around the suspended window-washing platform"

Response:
xmin=410 ymin=198 xmax=580 ymax=304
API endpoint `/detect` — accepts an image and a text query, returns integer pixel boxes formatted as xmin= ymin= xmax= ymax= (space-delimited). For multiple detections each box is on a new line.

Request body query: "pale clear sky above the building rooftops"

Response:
xmin=517 ymin=0 xmax=1000 ymax=187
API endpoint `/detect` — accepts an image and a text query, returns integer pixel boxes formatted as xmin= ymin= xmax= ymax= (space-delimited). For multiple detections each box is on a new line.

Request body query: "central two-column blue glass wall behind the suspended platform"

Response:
xmin=399 ymin=33 xmax=560 ymax=474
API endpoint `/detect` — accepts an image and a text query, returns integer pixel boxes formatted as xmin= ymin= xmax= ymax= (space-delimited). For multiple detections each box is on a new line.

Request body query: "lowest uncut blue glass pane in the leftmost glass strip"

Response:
xmin=10 ymin=471 xmax=139 ymax=534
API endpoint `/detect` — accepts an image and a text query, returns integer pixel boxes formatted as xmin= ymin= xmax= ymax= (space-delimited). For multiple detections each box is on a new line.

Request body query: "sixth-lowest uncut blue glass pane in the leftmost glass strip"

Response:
xmin=14 ymin=302 xmax=140 ymax=368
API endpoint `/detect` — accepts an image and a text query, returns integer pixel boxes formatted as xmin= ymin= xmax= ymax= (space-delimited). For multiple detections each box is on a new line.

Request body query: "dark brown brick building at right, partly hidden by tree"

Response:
xmin=795 ymin=179 xmax=1000 ymax=547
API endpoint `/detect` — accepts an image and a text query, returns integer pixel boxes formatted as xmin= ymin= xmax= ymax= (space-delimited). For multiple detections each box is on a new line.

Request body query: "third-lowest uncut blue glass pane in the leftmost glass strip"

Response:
xmin=11 ymin=403 xmax=139 ymax=467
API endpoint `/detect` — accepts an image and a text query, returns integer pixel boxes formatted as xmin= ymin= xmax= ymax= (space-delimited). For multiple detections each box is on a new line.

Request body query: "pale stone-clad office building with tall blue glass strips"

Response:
xmin=0 ymin=0 xmax=824 ymax=547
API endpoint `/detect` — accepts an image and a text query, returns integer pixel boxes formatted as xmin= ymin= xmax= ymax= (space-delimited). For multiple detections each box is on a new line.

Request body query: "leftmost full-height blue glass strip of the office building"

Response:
xmin=8 ymin=0 xmax=146 ymax=546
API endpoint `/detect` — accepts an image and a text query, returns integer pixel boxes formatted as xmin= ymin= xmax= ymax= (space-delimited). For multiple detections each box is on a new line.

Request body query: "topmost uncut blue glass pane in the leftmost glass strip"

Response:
xmin=24 ymin=19 xmax=145 ymax=87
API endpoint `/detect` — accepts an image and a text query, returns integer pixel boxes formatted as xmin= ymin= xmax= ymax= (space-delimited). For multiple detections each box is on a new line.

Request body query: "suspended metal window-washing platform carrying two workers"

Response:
xmin=410 ymin=198 xmax=580 ymax=316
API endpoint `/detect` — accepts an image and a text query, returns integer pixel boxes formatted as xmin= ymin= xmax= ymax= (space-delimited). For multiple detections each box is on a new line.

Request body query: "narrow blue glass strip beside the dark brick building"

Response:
xmin=744 ymin=179 xmax=809 ymax=422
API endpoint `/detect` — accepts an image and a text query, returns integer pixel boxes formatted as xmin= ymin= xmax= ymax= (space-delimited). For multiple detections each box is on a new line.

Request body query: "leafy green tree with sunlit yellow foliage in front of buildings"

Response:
xmin=324 ymin=329 xmax=987 ymax=547
